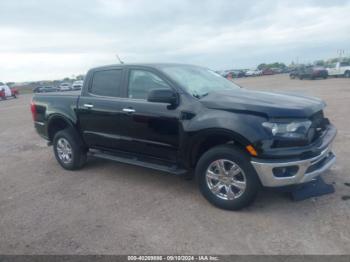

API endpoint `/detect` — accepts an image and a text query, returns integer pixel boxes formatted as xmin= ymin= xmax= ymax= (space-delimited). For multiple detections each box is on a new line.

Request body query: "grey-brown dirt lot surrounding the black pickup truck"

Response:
xmin=0 ymin=75 xmax=350 ymax=254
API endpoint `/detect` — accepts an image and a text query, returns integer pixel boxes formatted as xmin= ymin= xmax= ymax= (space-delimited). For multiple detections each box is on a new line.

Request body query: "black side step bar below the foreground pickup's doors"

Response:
xmin=88 ymin=150 xmax=187 ymax=175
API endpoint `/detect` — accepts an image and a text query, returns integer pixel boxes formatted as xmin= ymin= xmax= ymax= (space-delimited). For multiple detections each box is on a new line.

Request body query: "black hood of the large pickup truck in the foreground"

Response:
xmin=199 ymin=88 xmax=325 ymax=118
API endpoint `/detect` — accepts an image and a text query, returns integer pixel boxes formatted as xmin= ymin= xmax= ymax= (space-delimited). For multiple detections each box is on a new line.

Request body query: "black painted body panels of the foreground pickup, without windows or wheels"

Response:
xmin=33 ymin=64 xmax=336 ymax=168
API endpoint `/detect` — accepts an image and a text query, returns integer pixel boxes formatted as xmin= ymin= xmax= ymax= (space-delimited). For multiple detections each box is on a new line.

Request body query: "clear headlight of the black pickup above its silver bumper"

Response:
xmin=262 ymin=120 xmax=311 ymax=138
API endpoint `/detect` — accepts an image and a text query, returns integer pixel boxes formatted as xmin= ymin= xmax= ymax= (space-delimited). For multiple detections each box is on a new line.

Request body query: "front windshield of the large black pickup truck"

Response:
xmin=161 ymin=66 xmax=240 ymax=98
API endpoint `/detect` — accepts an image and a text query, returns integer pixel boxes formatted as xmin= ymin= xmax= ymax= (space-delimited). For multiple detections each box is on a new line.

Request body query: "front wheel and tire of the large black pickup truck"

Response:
xmin=196 ymin=145 xmax=260 ymax=210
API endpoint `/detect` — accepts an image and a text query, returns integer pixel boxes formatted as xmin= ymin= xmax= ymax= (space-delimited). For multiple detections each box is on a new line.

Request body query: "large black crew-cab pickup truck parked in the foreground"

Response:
xmin=31 ymin=64 xmax=336 ymax=210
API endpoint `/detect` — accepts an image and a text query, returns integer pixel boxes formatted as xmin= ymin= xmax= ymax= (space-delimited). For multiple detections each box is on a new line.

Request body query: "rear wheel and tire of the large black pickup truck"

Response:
xmin=53 ymin=128 xmax=87 ymax=170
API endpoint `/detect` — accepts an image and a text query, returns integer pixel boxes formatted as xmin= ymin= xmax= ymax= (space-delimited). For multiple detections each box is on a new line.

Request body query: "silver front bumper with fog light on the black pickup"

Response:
xmin=251 ymin=126 xmax=336 ymax=187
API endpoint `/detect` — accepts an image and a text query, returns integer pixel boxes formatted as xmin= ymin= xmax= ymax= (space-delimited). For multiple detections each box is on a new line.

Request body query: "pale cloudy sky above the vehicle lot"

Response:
xmin=0 ymin=0 xmax=350 ymax=82
